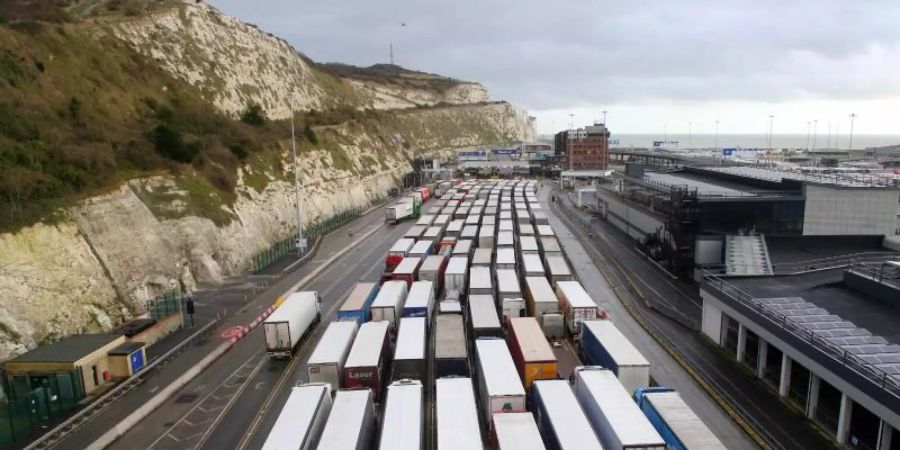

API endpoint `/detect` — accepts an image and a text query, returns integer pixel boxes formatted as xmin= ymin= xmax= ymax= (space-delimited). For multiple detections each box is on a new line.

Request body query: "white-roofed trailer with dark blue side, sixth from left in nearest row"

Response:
xmin=531 ymin=380 xmax=603 ymax=450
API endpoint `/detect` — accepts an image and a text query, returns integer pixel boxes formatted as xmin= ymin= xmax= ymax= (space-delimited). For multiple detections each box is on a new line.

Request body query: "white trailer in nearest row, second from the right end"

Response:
xmin=575 ymin=366 xmax=666 ymax=450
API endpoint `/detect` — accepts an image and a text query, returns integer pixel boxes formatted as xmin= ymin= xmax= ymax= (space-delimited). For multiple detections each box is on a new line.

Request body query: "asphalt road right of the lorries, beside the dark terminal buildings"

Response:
xmin=551 ymin=184 xmax=833 ymax=449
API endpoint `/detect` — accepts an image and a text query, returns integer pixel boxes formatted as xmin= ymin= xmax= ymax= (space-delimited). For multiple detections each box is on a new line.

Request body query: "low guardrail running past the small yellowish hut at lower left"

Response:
xmin=25 ymin=319 xmax=218 ymax=450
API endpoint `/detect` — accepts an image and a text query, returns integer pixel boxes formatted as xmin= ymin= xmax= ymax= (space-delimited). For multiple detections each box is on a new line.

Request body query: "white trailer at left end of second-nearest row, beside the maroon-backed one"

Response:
xmin=306 ymin=321 xmax=359 ymax=390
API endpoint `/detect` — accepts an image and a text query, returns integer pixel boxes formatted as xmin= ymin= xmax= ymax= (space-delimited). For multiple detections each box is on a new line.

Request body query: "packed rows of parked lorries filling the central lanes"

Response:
xmin=264 ymin=180 xmax=724 ymax=450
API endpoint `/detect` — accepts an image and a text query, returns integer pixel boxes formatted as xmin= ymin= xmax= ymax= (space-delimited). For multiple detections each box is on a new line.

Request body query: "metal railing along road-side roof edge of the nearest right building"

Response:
xmin=703 ymin=271 xmax=900 ymax=398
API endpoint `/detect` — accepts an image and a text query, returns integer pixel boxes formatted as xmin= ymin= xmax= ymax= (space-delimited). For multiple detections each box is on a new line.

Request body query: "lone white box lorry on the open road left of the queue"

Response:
xmin=263 ymin=291 xmax=322 ymax=358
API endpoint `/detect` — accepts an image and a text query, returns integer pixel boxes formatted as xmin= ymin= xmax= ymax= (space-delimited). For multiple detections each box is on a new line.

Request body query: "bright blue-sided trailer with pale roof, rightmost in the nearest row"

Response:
xmin=634 ymin=387 xmax=725 ymax=450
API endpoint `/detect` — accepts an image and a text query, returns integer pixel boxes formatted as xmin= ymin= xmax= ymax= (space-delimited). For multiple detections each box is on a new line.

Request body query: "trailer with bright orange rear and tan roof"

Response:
xmin=507 ymin=317 xmax=559 ymax=389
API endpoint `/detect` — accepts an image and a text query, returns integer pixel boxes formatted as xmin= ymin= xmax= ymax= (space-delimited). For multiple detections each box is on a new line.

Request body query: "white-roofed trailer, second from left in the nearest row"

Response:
xmin=318 ymin=388 xmax=377 ymax=450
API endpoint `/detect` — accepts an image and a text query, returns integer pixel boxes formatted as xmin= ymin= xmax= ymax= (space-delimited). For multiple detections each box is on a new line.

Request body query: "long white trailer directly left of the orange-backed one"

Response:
xmin=475 ymin=338 xmax=526 ymax=427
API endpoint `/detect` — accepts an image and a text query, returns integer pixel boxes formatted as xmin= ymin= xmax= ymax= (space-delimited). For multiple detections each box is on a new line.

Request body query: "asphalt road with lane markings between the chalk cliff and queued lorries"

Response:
xmin=99 ymin=203 xmax=409 ymax=450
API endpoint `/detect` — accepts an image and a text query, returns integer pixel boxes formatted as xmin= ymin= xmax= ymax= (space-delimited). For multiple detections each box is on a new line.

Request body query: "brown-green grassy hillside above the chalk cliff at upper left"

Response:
xmin=0 ymin=11 xmax=287 ymax=230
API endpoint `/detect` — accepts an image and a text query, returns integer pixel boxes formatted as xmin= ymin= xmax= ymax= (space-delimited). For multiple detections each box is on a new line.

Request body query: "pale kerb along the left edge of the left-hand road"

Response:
xmin=86 ymin=220 xmax=384 ymax=450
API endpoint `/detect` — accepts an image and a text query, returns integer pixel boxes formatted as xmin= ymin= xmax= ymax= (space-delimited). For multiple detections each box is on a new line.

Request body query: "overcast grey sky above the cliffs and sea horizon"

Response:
xmin=210 ymin=0 xmax=900 ymax=134
